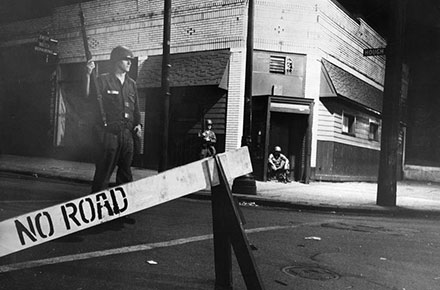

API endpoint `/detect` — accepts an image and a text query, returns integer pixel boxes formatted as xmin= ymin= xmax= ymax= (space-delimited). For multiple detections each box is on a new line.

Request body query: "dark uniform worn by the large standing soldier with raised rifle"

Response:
xmin=92 ymin=46 xmax=141 ymax=192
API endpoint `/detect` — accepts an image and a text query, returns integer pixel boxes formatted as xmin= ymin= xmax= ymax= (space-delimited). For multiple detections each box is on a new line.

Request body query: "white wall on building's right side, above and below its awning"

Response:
xmin=312 ymin=0 xmax=386 ymax=153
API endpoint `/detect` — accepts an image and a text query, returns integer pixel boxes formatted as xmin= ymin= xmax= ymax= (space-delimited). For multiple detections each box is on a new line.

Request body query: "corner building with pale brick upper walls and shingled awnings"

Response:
xmin=0 ymin=0 xmax=404 ymax=182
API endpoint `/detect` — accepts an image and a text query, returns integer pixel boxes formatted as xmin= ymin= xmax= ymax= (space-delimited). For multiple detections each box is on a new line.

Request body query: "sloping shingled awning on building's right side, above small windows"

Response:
xmin=319 ymin=59 xmax=383 ymax=112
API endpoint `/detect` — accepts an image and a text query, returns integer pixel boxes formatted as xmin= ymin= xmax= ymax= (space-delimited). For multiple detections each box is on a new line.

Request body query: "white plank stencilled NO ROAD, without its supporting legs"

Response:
xmin=0 ymin=147 xmax=252 ymax=257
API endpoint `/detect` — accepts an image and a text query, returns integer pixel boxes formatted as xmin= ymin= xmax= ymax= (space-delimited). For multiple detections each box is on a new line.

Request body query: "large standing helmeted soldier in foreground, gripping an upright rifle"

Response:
xmin=85 ymin=46 xmax=142 ymax=192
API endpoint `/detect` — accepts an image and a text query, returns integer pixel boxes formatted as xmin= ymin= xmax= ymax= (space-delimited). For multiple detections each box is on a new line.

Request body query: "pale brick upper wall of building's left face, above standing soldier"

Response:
xmin=0 ymin=0 xmax=245 ymax=63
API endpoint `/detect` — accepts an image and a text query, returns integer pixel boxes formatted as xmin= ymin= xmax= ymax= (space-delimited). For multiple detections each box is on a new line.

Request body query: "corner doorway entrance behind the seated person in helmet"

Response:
xmin=252 ymin=95 xmax=313 ymax=183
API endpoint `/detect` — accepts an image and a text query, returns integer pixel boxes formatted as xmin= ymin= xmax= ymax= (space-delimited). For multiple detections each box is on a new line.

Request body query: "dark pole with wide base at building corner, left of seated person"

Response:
xmin=232 ymin=0 xmax=257 ymax=194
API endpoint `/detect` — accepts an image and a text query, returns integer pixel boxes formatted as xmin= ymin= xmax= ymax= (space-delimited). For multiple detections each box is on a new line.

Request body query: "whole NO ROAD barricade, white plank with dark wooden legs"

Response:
xmin=0 ymin=147 xmax=264 ymax=290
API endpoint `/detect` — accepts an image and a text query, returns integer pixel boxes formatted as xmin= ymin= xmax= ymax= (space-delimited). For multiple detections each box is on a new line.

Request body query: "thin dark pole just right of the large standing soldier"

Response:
xmin=159 ymin=0 xmax=171 ymax=172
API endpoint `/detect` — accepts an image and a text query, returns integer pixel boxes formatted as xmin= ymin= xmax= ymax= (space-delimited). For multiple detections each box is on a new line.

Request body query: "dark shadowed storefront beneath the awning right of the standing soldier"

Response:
xmin=143 ymin=86 xmax=227 ymax=169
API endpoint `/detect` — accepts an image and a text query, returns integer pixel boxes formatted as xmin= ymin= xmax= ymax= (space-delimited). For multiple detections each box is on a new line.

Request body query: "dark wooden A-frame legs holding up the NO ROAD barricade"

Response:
xmin=211 ymin=156 xmax=264 ymax=290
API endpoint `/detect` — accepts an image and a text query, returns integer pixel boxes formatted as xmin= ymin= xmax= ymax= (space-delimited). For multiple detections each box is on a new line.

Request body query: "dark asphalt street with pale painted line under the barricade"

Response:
xmin=0 ymin=175 xmax=440 ymax=290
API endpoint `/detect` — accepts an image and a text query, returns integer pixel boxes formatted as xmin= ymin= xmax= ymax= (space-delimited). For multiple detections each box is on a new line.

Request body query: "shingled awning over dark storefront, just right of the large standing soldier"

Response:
xmin=137 ymin=49 xmax=230 ymax=88
